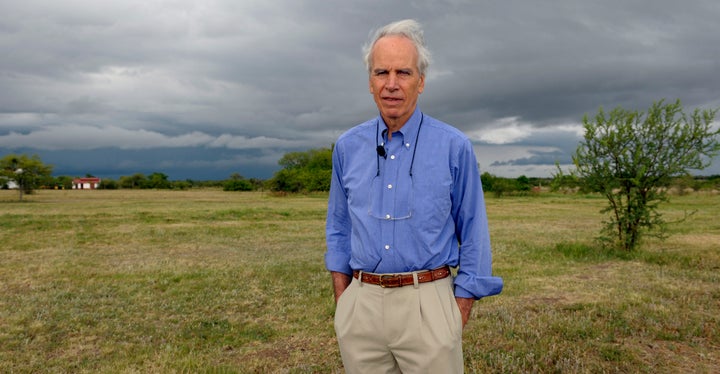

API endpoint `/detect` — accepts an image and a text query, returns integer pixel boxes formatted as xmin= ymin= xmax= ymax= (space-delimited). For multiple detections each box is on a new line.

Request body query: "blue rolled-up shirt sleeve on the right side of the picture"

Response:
xmin=453 ymin=140 xmax=503 ymax=299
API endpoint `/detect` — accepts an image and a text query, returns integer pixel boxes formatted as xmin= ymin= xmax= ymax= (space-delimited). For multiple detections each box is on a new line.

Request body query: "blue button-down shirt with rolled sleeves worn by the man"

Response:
xmin=325 ymin=109 xmax=503 ymax=299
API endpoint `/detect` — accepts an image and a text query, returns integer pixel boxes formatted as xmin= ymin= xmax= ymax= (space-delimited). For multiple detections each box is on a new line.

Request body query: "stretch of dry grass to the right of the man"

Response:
xmin=465 ymin=191 xmax=720 ymax=373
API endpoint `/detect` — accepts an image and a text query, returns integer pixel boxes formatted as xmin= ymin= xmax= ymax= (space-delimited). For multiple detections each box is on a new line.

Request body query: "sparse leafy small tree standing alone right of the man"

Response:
xmin=573 ymin=100 xmax=720 ymax=251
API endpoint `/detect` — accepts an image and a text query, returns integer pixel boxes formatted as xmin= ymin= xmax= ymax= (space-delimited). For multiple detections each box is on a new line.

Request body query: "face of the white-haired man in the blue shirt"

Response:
xmin=370 ymin=36 xmax=425 ymax=131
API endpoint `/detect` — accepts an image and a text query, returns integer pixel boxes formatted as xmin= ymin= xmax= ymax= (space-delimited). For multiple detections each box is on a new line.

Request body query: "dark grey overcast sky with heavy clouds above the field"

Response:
xmin=0 ymin=0 xmax=720 ymax=180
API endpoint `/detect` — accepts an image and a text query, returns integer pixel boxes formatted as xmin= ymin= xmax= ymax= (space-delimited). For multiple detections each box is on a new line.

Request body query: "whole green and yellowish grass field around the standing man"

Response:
xmin=0 ymin=190 xmax=720 ymax=373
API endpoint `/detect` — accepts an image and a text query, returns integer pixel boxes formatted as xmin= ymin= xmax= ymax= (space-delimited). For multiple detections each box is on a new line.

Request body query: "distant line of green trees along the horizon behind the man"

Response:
xmin=0 ymin=148 xmax=720 ymax=197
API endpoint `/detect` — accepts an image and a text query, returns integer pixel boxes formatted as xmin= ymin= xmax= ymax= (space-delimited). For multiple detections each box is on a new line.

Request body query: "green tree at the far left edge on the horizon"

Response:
xmin=0 ymin=154 xmax=52 ymax=201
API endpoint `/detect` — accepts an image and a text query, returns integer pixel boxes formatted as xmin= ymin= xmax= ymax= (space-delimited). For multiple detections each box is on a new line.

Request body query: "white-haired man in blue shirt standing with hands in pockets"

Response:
xmin=325 ymin=20 xmax=502 ymax=373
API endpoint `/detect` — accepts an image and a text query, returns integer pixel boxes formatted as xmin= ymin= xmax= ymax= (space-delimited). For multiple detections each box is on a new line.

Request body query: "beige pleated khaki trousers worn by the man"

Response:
xmin=335 ymin=277 xmax=463 ymax=373
